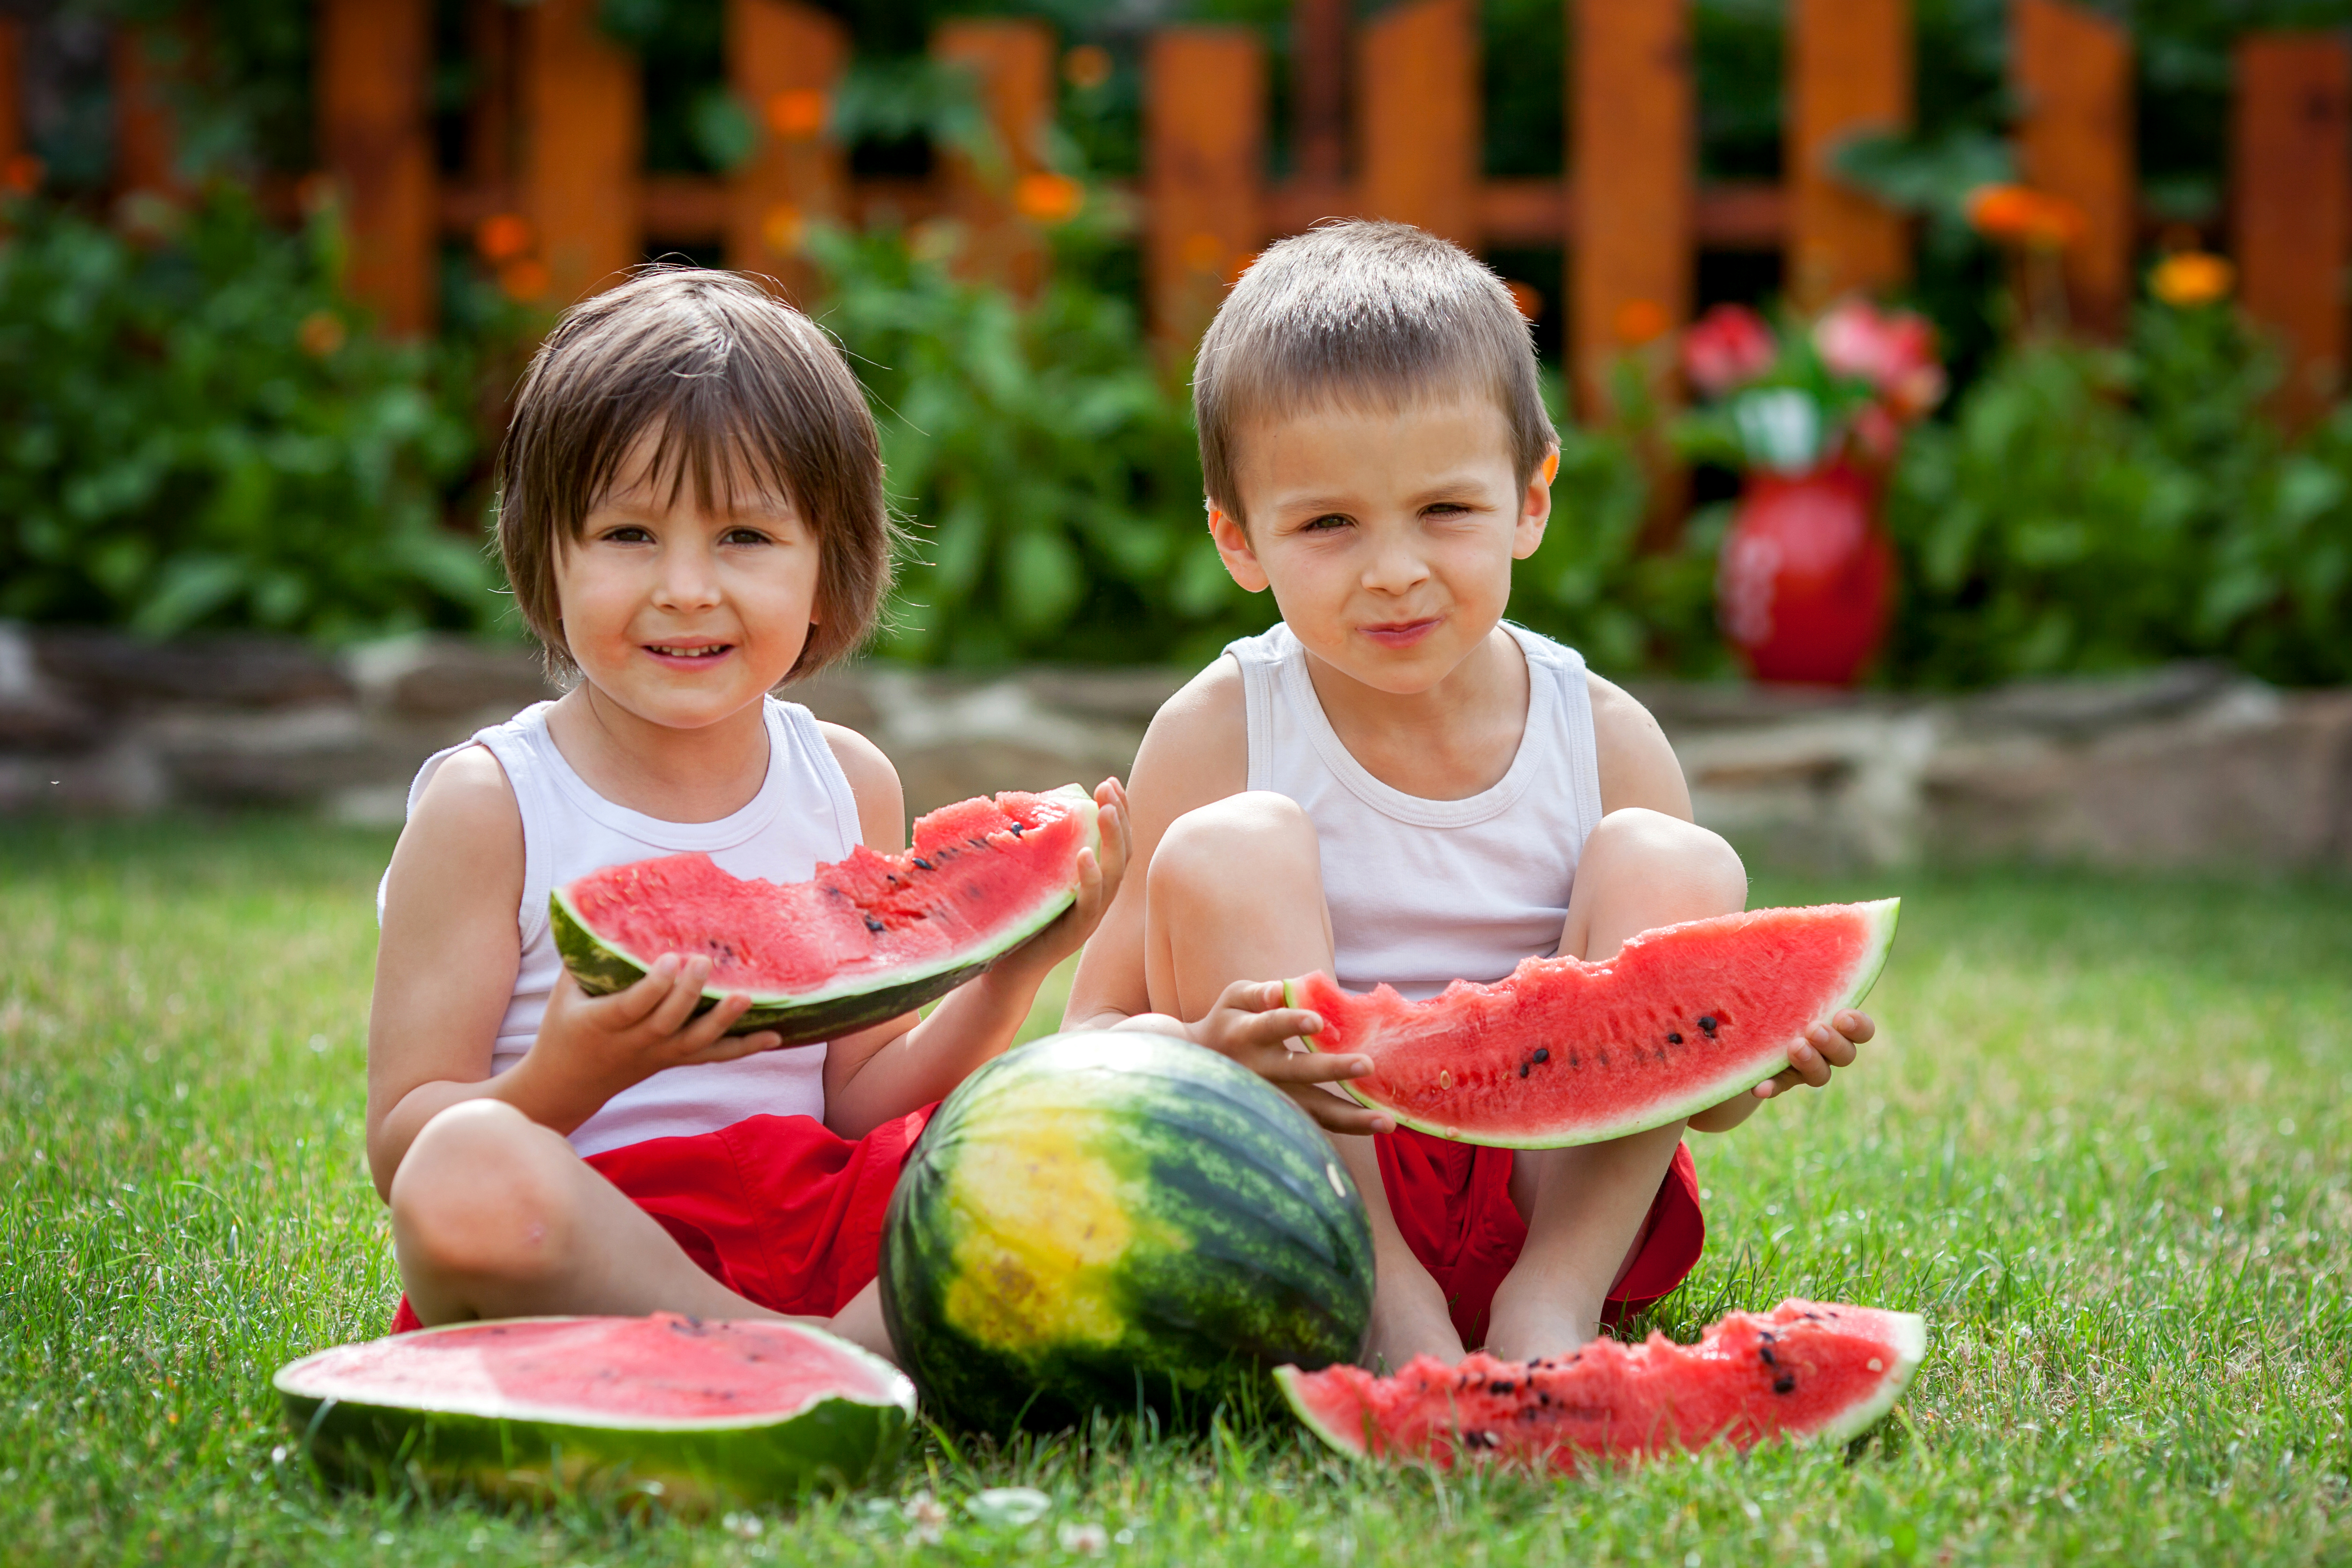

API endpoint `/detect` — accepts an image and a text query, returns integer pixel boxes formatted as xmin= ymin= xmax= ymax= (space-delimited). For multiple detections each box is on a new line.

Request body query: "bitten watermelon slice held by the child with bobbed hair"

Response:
xmin=548 ymin=785 xmax=1101 ymax=1046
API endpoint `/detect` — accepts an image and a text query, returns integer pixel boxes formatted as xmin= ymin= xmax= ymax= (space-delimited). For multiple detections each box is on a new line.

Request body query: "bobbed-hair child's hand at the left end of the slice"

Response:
xmin=518 ymin=952 xmax=783 ymax=1119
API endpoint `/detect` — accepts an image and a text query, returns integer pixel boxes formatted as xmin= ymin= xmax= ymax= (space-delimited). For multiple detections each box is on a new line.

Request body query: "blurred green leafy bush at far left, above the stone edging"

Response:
xmin=0 ymin=186 xmax=501 ymax=639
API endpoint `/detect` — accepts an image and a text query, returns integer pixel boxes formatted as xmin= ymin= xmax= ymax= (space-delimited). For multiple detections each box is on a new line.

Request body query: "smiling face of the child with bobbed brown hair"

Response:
xmin=555 ymin=440 xmax=816 ymax=729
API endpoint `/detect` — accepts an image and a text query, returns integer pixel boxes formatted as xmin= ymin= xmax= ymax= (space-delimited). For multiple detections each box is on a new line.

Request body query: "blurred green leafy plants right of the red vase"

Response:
xmin=1886 ymin=303 xmax=2352 ymax=686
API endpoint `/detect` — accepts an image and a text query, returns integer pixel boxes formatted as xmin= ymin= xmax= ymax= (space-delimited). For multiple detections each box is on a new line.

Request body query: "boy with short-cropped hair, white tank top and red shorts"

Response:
xmin=1070 ymin=223 xmax=1872 ymax=1366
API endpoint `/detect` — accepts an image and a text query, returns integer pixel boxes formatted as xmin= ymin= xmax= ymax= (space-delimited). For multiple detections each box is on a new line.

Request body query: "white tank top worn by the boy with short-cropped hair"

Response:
xmin=1225 ymin=623 xmax=1602 ymax=997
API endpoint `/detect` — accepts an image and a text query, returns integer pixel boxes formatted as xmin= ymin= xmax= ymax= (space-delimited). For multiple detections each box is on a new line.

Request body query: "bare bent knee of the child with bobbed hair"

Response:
xmin=391 ymin=1100 xmax=576 ymax=1276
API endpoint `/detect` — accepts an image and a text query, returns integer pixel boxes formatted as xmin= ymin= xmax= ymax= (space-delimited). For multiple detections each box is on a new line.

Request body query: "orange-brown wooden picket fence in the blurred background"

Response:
xmin=0 ymin=0 xmax=2352 ymax=414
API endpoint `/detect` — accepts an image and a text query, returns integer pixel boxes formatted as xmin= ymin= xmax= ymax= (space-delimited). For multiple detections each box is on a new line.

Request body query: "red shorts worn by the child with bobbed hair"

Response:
xmin=391 ymin=1105 xmax=932 ymax=1333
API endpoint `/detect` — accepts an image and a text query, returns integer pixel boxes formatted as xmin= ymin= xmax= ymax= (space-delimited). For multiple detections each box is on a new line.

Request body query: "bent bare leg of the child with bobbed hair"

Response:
xmin=391 ymin=1100 xmax=889 ymax=1357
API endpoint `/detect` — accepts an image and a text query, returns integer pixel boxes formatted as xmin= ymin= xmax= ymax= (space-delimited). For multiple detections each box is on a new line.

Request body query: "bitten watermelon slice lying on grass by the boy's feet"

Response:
xmin=1275 ymin=1298 xmax=1926 ymax=1469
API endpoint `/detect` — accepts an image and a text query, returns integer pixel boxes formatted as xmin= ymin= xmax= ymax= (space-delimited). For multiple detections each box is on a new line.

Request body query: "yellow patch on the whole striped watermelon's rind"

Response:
xmin=943 ymin=1112 xmax=1183 ymax=1354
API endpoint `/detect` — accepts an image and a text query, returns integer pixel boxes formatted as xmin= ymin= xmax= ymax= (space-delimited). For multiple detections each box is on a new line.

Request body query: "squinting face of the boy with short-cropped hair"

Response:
xmin=1209 ymin=398 xmax=1552 ymax=696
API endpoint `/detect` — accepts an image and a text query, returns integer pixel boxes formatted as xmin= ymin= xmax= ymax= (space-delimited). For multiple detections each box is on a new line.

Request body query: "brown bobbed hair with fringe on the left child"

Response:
xmin=499 ymin=268 xmax=898 ymax=677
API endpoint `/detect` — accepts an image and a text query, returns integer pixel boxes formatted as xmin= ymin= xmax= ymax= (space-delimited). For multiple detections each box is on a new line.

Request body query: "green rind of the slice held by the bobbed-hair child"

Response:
xmin=548 ymin=785 xmax=1103 ymax=1046
